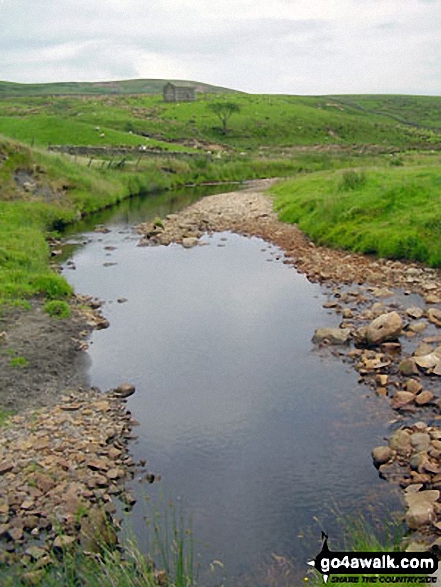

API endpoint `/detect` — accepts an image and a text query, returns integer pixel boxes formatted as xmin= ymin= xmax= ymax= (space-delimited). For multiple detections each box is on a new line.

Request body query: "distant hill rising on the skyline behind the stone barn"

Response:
xmin=0 ymin=79 xmax=235 ymax=97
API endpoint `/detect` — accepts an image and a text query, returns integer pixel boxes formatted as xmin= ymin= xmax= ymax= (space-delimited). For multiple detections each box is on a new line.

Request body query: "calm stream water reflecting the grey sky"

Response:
xmin=61 ymin=188 xmax=397 ymax=586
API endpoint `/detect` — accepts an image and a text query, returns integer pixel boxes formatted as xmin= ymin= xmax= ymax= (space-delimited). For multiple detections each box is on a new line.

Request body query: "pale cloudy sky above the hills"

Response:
xmin=0 ymin=0 xmax=441 ymax=95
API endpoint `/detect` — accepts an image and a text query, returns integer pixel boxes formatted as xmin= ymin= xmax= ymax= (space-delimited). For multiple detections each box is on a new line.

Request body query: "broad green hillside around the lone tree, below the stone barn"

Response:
xmin=0 ymin=91 xmax=441 ymax=156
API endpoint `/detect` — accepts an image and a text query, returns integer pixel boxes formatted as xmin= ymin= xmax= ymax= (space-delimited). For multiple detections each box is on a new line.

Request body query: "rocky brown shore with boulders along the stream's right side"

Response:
xmin=138 ymin=180 xmax=441 ymax=546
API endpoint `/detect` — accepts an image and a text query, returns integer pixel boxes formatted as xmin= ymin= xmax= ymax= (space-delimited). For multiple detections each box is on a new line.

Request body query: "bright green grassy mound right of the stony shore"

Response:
xmin=272 ymin=167 xmax=441 ymax=267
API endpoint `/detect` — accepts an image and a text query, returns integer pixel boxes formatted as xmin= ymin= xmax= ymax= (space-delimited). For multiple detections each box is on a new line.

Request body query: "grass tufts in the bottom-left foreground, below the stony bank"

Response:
xmin=0 ymin=504 xmax=198 ymax=587
